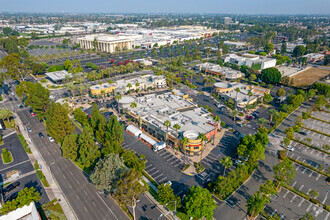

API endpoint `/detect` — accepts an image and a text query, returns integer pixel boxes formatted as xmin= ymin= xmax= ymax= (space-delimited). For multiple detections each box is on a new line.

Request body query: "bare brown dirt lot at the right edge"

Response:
xmin=290 ymin=67 xmax=330 ymax=86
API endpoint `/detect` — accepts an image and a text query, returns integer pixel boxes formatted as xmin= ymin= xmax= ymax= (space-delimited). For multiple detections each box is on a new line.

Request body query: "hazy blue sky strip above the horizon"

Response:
xmin=0 ymin=0 xmax=330 ymax=14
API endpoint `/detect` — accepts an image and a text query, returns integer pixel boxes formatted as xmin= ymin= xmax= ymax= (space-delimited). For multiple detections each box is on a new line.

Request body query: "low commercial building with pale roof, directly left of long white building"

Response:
xmin=197 ymin=63 xmax=244 ymax=80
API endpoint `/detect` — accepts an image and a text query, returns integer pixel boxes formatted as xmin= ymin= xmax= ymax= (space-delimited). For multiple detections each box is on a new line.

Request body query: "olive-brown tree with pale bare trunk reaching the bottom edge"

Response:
xmin=117 ymin=169 xmax=148 ymax=220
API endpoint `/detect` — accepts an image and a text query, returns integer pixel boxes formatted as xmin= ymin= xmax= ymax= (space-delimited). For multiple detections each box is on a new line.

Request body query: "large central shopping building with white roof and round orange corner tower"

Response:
xmin=119 ymin=91 xmax=218 ymax=156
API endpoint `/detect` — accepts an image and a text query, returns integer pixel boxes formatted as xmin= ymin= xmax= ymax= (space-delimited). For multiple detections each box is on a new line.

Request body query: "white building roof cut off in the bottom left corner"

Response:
xmin=0 ymin=202 xmax=41 ymax=220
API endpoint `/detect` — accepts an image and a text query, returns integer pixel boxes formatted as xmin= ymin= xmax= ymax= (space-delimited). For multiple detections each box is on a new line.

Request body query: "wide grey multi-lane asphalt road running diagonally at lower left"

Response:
xmin=18 ymin=109 xmax=128 ymax=220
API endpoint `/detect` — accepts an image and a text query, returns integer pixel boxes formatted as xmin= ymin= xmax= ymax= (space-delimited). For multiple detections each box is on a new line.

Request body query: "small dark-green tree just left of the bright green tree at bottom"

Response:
xmin=157 ymin=183 xmax=181 ymax=210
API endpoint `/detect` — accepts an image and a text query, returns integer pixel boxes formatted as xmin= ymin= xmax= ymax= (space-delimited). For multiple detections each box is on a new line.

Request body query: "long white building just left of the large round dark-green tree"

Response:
xmin=225 ymin=54 xmax=276 ymax=70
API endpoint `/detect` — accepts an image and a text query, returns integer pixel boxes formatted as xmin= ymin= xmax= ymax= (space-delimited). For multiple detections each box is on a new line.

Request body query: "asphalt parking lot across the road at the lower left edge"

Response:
xmin=0 ymin=133 xmax=49 ymax=204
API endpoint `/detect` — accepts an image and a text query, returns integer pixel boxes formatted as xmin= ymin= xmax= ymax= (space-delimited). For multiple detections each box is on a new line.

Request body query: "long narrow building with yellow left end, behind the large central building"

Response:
xmin=90 ymin=74 xmax=167 ymax=97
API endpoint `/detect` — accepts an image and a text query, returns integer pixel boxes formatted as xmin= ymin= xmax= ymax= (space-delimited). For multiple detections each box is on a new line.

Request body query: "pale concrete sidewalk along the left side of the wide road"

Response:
xmin=15 ymin=113 xmax=78 ymax=220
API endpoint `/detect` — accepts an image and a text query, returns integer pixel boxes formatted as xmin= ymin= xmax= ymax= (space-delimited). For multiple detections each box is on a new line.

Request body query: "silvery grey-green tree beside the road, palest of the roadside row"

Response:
xmin=90 ymin=154 xmax=127 ymax=192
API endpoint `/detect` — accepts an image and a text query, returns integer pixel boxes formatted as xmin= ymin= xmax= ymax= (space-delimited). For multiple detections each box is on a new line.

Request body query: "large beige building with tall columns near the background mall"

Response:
xmin=77 ymin=34 xmax=135 ymax=53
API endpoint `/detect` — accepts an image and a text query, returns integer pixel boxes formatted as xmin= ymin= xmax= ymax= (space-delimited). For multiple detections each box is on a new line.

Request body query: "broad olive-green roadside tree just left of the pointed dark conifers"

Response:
xmin=46 ymin=102 xmax=75 ymax=143
